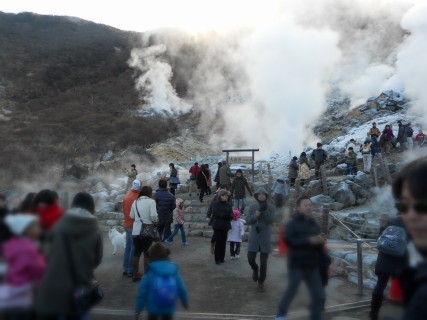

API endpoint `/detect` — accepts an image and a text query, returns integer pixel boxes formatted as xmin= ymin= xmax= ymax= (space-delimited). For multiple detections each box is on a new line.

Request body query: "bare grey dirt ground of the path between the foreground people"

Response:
xmin=92 ymin=235 xmax=399 ymax=319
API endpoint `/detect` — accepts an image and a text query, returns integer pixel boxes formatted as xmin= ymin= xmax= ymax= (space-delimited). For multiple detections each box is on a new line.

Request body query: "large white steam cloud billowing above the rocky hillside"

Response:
xmin=130 ymin=0 xmax=427 ymax=153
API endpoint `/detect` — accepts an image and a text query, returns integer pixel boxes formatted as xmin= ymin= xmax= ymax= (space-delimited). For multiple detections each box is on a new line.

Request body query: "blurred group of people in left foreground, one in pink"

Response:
xmin=0 ymin=190 xmax=103 ymax=319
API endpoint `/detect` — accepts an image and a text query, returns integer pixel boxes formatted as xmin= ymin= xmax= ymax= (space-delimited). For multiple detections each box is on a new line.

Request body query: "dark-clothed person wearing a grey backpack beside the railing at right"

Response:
xmin=369 ymin=214 xmax=408 ymax=320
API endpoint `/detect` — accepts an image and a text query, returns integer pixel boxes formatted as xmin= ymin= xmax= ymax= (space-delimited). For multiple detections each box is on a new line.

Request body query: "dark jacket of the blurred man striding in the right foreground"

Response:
xmin=285 ymin=212 xmax=322 ymax=269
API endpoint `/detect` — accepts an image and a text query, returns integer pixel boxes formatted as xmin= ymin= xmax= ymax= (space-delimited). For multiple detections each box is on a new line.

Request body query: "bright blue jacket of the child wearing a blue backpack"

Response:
xmin=135 ymin=260 xmax=188 ymax=316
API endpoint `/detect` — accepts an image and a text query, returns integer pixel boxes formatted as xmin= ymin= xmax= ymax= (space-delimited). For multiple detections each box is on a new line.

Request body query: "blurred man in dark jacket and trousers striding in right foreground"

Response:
xmin=276 ymin=196 xmax=325 ymax=320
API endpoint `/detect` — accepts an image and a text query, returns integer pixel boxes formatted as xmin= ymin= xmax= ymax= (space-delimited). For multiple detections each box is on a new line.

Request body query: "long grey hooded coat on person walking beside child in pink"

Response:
xmin=246 ymin=188 xmax=275 ymax=253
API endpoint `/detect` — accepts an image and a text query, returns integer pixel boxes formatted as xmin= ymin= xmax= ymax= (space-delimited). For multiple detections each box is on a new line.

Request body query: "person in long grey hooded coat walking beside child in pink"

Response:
xmin=246 ymin=188 xmax=275 ymax=292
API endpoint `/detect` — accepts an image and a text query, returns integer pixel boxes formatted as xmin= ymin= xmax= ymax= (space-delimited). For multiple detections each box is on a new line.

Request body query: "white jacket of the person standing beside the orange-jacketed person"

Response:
xmin=130 ymin=196 xmax=159 ymax=236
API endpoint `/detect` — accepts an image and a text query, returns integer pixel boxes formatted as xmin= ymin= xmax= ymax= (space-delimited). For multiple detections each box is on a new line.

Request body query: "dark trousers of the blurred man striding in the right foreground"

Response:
xmin=277 ymin=268 xmax=325 ymax=320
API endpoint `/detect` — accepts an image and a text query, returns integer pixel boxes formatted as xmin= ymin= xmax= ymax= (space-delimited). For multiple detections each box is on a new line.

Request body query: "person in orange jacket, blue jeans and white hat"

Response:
xmin=123 ymin=180 xmax=141 ymax=277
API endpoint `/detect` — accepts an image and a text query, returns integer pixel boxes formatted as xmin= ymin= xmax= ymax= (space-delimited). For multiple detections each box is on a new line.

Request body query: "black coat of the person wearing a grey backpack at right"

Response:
xmin=375 ymin=216 xmax=408 ymax=276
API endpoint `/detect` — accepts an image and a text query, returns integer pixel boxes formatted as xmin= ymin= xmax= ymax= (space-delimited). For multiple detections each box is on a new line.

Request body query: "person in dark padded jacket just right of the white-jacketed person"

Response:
xmin=154 ymin=179 xmax=176 ymax=241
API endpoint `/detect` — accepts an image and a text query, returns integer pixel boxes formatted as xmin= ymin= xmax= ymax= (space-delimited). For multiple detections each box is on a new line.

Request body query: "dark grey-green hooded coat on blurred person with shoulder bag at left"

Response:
xmin=35 ymin=208 xmax=103 ymax=316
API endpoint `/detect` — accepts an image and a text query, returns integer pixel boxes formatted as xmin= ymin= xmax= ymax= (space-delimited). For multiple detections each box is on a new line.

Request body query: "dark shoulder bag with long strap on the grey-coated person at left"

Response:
xmin=62 ymin=234 xmax=104 ymax=315
